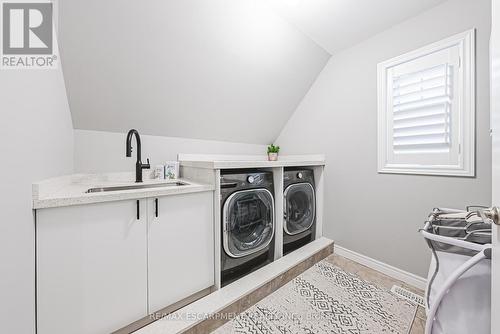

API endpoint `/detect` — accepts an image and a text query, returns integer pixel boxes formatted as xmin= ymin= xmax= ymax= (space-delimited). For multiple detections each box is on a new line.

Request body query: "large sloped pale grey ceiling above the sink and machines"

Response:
xmin=59 ymin=0 xmax=330 ymax=144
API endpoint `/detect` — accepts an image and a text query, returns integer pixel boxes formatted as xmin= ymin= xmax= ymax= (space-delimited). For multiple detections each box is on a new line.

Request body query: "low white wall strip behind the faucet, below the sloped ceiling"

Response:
xmin=75 ymin=129 xmax=267 ymax=173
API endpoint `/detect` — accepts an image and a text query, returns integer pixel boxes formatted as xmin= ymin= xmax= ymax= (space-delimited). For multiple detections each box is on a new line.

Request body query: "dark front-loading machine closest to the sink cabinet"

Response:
xmin=220 ymin=170 xmax=275 ymax=286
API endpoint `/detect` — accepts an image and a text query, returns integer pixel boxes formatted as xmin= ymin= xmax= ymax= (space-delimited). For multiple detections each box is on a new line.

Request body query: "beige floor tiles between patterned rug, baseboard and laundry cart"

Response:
xmin=325 ymin=254 xmax=426 ymax=334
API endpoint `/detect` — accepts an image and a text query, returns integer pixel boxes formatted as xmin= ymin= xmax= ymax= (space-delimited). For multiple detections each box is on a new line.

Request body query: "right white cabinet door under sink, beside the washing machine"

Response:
xmin=148 ymin=192 xmax=214 ymax=312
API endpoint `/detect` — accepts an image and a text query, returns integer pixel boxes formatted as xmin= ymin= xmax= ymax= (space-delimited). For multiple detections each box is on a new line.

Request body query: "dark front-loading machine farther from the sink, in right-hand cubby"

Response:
xmin=283 ymin=169 xmax=316 ymax=254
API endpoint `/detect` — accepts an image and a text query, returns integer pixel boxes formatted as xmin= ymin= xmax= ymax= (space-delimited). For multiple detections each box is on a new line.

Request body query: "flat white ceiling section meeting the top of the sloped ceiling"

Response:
xmin=269 ymin=0 xmax=446 ymax=54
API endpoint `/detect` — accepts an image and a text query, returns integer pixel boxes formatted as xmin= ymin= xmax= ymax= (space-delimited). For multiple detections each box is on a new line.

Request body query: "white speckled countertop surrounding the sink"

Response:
xmin=33 ymin=173 xmax=214 ymax=209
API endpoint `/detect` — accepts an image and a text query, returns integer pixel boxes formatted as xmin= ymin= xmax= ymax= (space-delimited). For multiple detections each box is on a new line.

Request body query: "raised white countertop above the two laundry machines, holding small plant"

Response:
xmin=178 ymin=154 xmax=326 ymax=169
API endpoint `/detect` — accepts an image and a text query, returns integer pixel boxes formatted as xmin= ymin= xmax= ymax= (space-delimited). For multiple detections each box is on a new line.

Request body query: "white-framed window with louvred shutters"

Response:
xmin=378 ymin=30 xmax=475 ymax=176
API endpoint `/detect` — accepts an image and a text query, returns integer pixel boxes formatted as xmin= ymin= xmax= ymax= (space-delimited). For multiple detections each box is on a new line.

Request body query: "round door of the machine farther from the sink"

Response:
xmin=283 ymin=183 xmax=316 ymax=235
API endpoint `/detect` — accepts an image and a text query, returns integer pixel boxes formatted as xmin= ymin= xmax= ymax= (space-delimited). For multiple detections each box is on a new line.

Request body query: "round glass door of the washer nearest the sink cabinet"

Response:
xmin=223 ymin=189 xmax=274 ymax=258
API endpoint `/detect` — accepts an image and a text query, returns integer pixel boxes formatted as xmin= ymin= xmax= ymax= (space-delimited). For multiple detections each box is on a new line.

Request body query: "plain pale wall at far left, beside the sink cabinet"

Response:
xmin=0 ymin=45 xmax=73 ymax=334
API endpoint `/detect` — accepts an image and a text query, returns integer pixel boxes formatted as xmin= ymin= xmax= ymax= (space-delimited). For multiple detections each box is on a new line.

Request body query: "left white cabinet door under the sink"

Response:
xmin=36 ymin=200 xmax=147 ymax=334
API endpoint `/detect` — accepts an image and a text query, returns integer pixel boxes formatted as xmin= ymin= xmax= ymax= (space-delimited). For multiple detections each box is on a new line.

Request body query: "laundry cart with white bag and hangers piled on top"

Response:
xmin=420 ymin=207 xmax=492 ymax=334
